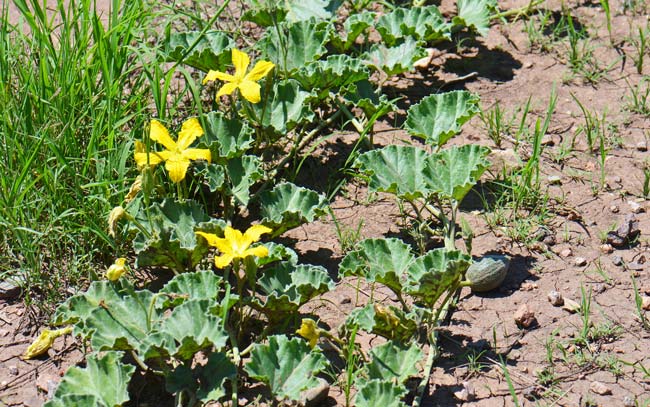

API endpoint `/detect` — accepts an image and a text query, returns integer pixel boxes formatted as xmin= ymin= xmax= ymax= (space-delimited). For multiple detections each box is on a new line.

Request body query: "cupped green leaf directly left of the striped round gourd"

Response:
xmin=403 ymin=248 xmax=472 ymax=307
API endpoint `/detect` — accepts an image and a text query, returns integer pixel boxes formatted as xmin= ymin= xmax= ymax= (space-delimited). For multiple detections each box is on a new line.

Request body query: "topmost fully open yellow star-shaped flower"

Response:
xmin=203 ymin=49 xmax=275 ymax=103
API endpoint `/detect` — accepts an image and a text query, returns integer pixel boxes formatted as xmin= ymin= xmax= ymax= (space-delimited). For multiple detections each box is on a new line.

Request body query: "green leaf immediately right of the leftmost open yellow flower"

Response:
xmin=201 ymin=112 xmax=253 ymax=164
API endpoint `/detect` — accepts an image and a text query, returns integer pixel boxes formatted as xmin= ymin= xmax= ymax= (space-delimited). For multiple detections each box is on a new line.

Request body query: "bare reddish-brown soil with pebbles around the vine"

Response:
xmin=0 ymin=0 xmax=650 ymax=406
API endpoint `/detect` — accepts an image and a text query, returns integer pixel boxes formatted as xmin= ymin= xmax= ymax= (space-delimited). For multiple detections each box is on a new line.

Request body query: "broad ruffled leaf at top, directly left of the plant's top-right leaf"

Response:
xmin=377 ymin=6 xmax=451 ymax=46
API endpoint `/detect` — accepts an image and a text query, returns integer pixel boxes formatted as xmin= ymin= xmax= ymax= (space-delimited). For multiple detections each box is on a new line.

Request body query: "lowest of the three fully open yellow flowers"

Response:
xmin=196 ymin=225 xmax=271 ymax=269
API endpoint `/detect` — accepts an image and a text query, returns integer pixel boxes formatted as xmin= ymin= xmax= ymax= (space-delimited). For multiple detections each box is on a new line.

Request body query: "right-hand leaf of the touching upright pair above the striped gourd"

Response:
xmin=427 ymin=144 xmax=490 ymax=202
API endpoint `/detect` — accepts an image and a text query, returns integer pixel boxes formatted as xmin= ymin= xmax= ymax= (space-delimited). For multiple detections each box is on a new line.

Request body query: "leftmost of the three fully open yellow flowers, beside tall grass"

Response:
xmin=135 ymin=118 xmax=212 ymax=182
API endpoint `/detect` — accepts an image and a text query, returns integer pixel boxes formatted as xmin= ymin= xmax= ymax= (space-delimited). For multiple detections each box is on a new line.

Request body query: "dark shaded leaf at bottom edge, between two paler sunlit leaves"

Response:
xmin=166 ymin=352 xmax=237 ymax=403
